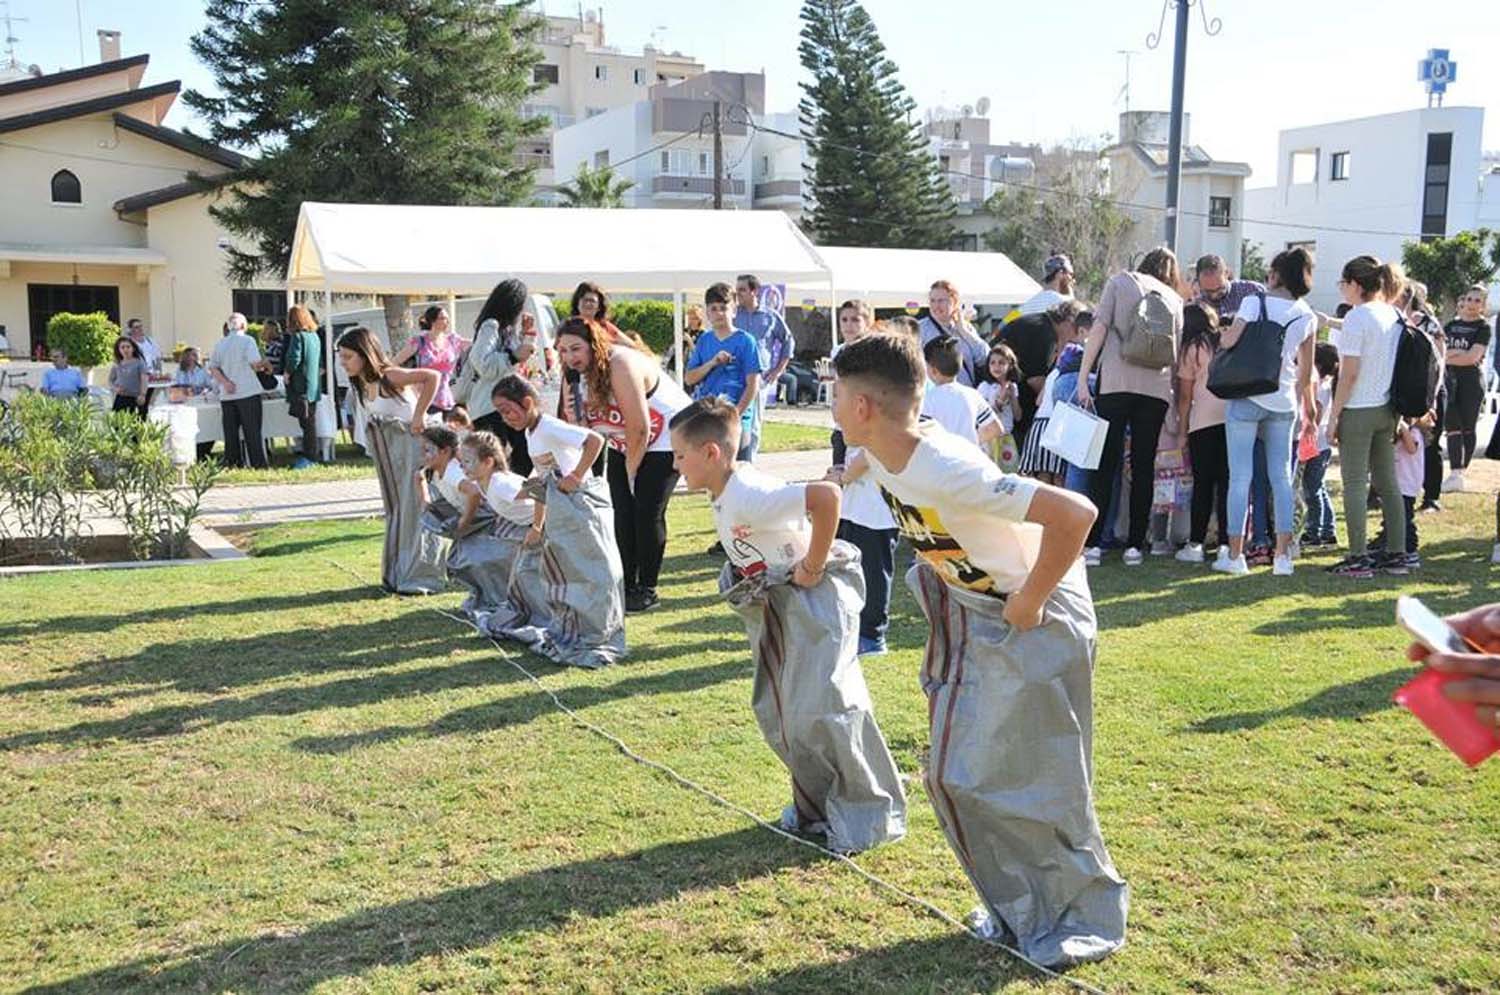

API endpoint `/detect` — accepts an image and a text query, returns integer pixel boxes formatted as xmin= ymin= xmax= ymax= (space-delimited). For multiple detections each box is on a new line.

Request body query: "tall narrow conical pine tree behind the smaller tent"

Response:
xmin=798 ymin=0 xmax=954 ymax=249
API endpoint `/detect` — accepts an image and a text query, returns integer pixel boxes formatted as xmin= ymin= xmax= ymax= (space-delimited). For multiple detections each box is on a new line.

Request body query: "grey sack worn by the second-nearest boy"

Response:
xmin=719 ymin=542 xmax=906 ymax=852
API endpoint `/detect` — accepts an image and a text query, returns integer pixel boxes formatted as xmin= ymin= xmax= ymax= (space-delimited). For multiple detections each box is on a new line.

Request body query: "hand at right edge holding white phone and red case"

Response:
xmin=1394 ymin=596 xmax=1500 ymax=767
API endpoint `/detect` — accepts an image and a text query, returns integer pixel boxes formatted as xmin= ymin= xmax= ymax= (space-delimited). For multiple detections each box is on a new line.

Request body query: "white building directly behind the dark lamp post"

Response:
xmin=1104 ymin=111 xmax=1250 ymax=273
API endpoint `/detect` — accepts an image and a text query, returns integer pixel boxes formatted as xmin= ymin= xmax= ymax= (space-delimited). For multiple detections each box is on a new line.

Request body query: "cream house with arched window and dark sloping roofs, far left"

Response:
xmin=0 ymin=41 xmax=267 ymax=366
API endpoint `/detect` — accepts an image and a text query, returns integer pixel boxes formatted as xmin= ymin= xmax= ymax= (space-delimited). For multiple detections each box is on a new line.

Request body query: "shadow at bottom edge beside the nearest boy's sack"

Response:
xmin=707 ymin=933 xmax=1040 ymax=995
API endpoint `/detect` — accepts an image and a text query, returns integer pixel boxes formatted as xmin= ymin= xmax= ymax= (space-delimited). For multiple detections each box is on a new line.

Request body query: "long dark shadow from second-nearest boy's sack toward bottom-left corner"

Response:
xmin=27 ymin=828 xmax=822 ymax=995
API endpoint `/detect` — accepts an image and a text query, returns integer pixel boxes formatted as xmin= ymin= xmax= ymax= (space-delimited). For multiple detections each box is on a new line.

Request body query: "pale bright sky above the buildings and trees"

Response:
xmin=11 ymin=0 xmax=1500 ymax=186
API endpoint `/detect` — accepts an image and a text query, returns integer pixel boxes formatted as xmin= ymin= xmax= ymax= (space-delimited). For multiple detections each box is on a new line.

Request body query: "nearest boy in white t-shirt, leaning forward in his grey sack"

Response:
xmin=834 ymin=335 xmax=1130 ymax=966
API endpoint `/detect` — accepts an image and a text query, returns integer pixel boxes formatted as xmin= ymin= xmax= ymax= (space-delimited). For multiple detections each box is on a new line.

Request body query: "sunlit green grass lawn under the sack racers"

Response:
xmin=0 ymin=497 xmax=1500 ymax=995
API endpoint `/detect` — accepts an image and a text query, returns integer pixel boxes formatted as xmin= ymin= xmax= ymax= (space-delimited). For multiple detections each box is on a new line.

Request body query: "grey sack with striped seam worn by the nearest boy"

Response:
xmin=906 ymin=561 xmax=1130 ymax=966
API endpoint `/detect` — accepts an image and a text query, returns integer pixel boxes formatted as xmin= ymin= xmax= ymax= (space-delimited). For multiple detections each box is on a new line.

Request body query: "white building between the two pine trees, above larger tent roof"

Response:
xmin=552 ymin=72 xmax=804 ymax=216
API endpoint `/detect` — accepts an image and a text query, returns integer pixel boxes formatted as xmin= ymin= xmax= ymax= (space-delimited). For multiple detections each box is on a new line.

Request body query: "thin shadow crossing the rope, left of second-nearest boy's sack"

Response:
xmin=293 ymin=660 xmax=750 ymax=753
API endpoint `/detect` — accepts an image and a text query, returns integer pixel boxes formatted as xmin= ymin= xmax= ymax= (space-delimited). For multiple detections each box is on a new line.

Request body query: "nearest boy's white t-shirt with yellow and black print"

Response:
xmin=866 ymin=426 xmax=1086 ymax=596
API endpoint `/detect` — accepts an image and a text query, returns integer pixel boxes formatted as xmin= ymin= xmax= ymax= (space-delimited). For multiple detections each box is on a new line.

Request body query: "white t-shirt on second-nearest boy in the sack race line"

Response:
xmin=713 ymin=464 xmax=813 ymax=572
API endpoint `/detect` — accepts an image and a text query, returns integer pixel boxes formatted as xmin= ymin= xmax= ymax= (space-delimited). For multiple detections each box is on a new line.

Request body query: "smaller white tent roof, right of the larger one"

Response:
xmin=786 ymin=246 xmax=1041 ymax=308
